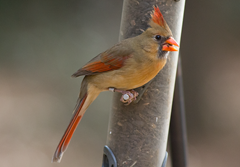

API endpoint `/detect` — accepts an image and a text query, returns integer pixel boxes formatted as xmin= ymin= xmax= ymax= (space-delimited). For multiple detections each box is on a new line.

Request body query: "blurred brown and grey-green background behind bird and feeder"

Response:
xmin=0 ymin=0 xmax=240 ymax=167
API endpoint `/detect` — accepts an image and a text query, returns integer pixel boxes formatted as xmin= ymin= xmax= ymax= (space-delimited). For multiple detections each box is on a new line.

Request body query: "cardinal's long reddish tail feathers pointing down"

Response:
xmin=52 ymin=93 xmax=87 ymax=162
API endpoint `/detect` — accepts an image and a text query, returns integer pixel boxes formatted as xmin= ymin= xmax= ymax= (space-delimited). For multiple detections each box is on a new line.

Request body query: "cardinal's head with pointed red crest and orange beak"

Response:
xmin=143 ymin=6 xmax=179 ymax=57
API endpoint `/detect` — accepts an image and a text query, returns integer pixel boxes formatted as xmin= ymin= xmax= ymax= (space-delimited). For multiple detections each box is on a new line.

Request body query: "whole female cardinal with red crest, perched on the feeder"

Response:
xmin=52 ymin=6 xmax=179 ymax=162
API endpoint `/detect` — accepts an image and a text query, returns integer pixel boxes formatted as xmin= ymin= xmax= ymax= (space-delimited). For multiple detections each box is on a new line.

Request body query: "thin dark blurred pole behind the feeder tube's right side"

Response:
xmin=169 ymin=55 xmax=187 ymax=167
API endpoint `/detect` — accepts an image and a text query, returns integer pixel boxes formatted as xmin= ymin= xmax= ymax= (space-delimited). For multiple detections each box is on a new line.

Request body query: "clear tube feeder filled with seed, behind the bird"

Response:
xmin=104 ymin=0 xmax=185 ymax=167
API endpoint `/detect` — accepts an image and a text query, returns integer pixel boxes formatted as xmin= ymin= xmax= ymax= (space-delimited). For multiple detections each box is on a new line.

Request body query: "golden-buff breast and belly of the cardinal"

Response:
xmin=91 ymin=59 xmax=166 ymax=90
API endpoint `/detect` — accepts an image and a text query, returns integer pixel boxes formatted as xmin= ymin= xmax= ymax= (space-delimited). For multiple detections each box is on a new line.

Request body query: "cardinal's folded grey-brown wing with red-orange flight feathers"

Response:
xmin=72 ymin=43 xmax=132 ymax=77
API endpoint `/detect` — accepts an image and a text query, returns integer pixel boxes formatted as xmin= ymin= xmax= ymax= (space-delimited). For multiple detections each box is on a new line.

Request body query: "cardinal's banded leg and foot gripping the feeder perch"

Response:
xmin=109 ymin=88 xmax=138 ymax=105
